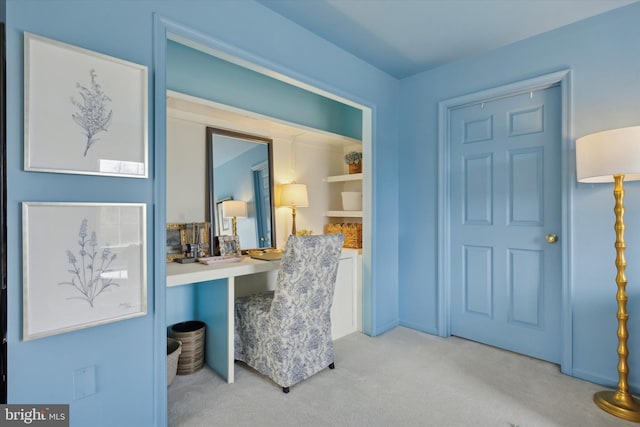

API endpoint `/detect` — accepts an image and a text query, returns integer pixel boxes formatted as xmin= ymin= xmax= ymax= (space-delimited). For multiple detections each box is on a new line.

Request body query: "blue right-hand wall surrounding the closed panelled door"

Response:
xmin=399 ymin=3 xmax=640 ymax=390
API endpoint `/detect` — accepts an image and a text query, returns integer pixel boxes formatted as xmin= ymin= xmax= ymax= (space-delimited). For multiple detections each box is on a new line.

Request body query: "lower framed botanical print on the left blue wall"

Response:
xmin=22 ymin=202 xmax=147 ymax=341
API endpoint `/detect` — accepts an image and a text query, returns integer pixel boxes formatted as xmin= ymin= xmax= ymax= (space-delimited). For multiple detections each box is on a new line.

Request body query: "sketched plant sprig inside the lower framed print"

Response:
xmin=59 ymin=219 xmax=120 ymax=307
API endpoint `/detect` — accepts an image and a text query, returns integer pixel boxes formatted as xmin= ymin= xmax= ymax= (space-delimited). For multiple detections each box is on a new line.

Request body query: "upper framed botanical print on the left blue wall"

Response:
xmin=24 ymin=32 xmax=148 ymax=178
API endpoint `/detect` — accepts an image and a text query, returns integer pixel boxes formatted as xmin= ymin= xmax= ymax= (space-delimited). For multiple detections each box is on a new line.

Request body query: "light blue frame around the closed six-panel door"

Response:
xmin=437 ymin=69 xmax=575 ymax=375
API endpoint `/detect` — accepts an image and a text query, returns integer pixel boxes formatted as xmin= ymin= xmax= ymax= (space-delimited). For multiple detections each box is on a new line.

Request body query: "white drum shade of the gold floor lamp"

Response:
xmin=576 ymin=126 xmax=640 ymax=183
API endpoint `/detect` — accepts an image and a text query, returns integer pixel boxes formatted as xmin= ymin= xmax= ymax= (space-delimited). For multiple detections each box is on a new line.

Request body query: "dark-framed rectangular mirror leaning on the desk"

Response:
xmin=206 ymin=127 xmax=276 ymax=253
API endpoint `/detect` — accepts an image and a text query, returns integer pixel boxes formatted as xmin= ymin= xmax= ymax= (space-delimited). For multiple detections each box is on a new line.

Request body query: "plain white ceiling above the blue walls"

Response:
xmin=258 ymin=0 xmax=638 ymax=78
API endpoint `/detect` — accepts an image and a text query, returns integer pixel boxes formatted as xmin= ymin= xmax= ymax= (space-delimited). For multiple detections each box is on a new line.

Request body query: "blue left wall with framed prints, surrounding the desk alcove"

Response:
xmin=6 ymin=0 xmax=398 ymax=426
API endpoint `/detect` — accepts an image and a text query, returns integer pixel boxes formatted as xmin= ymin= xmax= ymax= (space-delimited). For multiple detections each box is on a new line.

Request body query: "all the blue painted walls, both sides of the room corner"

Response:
xmin=6 ymin=0 xmax=640 ymax=426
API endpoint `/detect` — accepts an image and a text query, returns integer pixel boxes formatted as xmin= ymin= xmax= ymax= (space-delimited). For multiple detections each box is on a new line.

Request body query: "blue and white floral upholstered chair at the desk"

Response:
xmin=235 ymin=234 xmax=344 ymax=393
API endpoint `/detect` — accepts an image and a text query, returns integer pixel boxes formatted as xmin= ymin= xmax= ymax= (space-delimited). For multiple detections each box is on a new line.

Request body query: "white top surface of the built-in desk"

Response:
xmin=167 ymin=256 xmax=280 ymax=287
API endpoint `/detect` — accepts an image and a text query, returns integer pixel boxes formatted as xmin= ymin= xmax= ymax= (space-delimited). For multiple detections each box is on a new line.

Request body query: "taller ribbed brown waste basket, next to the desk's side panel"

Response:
xmin=170 ymin=320 xmax=205 ymax=375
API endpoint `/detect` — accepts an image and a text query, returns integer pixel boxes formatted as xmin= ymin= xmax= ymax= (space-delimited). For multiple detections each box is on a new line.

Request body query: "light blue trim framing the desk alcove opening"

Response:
xmin=151 ymin=14 xmax=376 ymax=426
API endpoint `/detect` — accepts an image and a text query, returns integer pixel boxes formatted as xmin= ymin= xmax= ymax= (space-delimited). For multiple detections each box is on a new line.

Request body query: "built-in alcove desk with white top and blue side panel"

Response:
xmin=167 ymin=257 xmax=280 ymax=383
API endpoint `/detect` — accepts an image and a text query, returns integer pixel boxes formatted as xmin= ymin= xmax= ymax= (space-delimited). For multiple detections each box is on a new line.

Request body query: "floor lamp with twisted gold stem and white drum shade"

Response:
xmin=576 ymin=126 xmax=640 ymax=422
